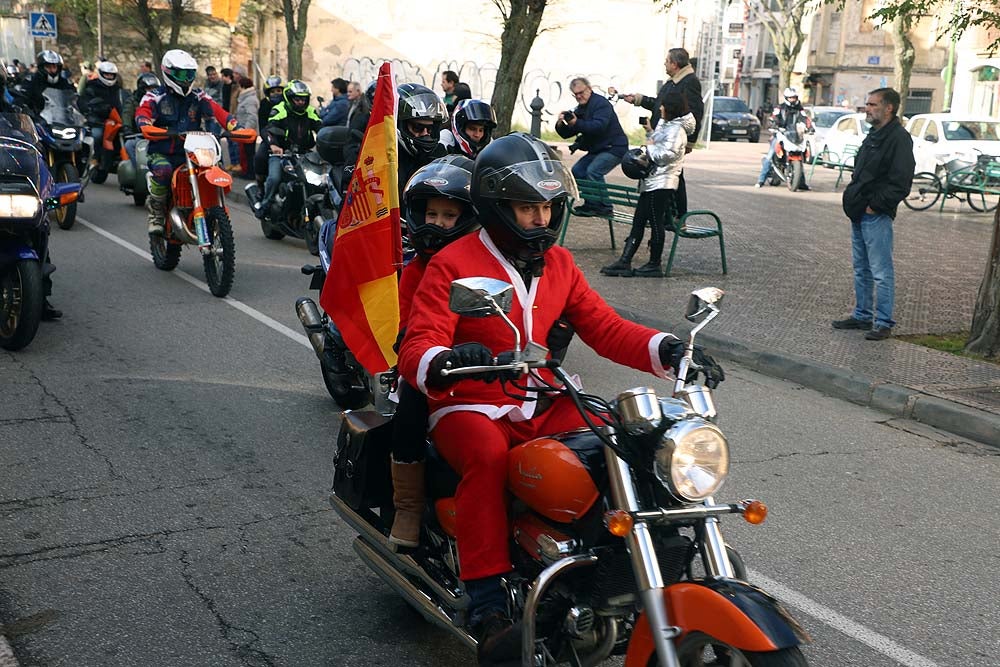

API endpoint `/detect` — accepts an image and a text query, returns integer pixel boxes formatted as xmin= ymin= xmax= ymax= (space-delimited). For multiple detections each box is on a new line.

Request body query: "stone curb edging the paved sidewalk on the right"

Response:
xmin=615 ymin=306 xmax=1000 ymax=448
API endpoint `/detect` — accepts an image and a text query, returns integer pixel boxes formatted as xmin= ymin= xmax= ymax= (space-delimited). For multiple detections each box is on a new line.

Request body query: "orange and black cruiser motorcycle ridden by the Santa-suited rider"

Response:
xmin=331 ymin=278 xmax=808 ymax=667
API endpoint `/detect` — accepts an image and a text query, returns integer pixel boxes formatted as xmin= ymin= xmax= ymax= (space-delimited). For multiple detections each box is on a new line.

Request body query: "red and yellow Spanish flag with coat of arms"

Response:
xmin=319 ymin=62 xmax=403 ymax=374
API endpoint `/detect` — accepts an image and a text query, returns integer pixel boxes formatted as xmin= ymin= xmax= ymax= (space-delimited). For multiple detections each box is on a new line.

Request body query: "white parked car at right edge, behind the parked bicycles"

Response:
xmin=906 ymin=113 xmax=1000 ymax=173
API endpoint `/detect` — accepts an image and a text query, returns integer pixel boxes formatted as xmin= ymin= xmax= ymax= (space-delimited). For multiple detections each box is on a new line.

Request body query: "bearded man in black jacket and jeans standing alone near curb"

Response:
xmin=833 ymin=88 xmax=914 ymax=340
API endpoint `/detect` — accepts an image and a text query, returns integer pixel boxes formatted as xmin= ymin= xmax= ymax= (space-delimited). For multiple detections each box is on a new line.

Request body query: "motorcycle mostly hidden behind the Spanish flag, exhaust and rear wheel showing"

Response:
xmin=295 ymin=218 xmax=378 ymax=410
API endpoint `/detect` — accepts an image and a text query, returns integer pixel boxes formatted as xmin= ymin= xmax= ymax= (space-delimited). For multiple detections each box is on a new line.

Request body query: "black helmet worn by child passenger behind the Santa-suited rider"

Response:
xmin=402 ymin=155 xmax=479 ymax=259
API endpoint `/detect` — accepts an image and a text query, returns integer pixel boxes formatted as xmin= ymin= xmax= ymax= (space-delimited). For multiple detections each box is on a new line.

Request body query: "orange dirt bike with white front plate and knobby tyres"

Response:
xmin=142 ymin=125 xmax=257 ymax=297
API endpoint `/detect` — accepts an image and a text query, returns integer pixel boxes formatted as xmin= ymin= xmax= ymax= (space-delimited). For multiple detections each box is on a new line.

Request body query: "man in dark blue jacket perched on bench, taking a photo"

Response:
xmin=556 ymin=77 xmax=628 ymax=215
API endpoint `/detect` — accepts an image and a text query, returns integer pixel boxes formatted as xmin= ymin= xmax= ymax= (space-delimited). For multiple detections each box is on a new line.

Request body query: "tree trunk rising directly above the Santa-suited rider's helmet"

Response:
xmin=490 ymin=0 xmax=545 ymax=137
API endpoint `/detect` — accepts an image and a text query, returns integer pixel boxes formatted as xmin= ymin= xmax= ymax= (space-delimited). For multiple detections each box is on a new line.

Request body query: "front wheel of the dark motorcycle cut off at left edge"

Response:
xmin=0 ymin=259 xmax=45 ymax=351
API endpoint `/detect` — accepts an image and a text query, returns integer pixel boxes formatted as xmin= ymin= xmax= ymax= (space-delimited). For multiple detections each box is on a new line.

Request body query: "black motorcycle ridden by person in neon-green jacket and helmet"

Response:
xmin=244 ymin=150 xmax=333 ymax=255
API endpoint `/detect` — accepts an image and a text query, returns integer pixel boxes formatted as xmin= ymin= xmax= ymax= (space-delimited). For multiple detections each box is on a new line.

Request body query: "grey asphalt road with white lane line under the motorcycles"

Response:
xmin=0 ymin=177 xmax=1000 ymax=667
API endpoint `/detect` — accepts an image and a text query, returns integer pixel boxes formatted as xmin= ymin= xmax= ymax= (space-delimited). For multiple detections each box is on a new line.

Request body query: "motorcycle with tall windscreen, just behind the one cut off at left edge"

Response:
xmin=35 ymin=88 xmax=93 ymax=229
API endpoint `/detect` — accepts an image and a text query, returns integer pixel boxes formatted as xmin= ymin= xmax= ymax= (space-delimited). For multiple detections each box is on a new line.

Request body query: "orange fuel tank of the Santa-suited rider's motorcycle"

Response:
xmin=507 ymin=430 xmax=607 ymax=523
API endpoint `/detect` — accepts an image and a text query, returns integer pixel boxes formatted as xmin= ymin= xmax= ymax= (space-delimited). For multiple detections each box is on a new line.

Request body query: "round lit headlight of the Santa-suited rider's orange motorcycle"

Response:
xmin=653 ymin=419 xmax=729 ymax=502
